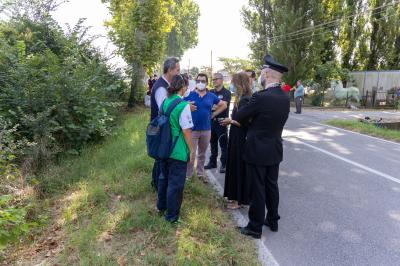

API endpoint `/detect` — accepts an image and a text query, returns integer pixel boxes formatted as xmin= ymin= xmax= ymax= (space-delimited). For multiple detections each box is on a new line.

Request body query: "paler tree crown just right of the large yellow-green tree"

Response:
xmin=166 ymin=0 xmax=200 ymax=58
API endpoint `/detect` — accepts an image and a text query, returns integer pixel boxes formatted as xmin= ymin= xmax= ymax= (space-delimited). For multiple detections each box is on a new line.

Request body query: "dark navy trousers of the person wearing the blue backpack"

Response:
xmin=157 ymin=159 xmax=187 ymax=222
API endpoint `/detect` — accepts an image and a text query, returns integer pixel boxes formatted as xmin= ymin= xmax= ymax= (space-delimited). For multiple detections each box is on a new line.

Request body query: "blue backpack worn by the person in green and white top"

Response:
xmin=146 ymin=98 xmax=183 ymax=160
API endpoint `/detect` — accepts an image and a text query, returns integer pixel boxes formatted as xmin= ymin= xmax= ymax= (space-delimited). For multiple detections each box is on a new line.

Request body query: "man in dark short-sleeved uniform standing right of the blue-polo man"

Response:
xmin=204 ymin=73 xmax=231 ymax=173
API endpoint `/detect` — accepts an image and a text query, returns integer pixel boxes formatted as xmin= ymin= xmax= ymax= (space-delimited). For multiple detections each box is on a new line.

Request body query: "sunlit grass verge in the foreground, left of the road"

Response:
xmin=5 ymin=109 xmax=258 ymax=265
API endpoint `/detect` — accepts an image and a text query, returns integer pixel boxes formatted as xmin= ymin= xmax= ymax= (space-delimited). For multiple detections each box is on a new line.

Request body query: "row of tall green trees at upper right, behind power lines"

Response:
xmin=242 ymin=0 xmax=400 ymax=83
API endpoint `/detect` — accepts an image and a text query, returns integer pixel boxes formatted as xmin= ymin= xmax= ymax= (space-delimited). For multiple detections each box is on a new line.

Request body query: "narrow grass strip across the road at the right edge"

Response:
xmin=324 ymin=119 xmax=400 ymax=142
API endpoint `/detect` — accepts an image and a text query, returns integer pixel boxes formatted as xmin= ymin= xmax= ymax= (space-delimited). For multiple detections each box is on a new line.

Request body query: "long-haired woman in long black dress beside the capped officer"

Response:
xmin=221 ymin=72 xmax=252 ymax=209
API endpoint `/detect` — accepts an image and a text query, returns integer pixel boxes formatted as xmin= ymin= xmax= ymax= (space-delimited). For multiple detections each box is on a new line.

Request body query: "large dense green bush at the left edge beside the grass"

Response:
xmin=0 ymin=18 xmax=125 ymax=166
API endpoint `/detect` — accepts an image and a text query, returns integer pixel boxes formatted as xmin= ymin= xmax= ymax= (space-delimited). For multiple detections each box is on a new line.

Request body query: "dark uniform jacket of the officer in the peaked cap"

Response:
xmin=236 ymin=86 xmax=290 ymax=166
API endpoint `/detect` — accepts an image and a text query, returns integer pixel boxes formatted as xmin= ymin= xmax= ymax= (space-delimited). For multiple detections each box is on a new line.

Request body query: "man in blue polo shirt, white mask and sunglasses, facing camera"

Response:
xmin=185 ymin=73 xmax=227 ymax=178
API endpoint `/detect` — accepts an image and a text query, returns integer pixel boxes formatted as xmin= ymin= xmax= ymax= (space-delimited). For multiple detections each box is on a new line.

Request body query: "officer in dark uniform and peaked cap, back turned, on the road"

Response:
xmin=236 ymin=55 xmax=290 ymax=239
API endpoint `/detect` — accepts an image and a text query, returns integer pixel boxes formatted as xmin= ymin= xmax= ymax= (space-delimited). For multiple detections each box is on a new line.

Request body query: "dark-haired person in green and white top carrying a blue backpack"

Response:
xmin=157 ymin=75 xmax=193 ymax=223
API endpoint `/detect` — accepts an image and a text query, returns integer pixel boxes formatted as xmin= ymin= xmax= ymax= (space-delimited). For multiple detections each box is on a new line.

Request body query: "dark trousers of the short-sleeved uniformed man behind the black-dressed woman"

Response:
xmin=210 ymin=121 xmax=228 ymax=166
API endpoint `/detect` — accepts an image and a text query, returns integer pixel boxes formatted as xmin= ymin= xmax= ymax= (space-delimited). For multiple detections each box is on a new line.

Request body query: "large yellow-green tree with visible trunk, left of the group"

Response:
xmin=103 ymin=0 xmax=174 ymax=107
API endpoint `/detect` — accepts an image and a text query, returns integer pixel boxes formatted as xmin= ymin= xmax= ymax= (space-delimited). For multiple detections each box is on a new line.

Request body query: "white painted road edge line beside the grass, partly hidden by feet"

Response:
xmin=207 ymin=171 xmax=279 ymax=266
